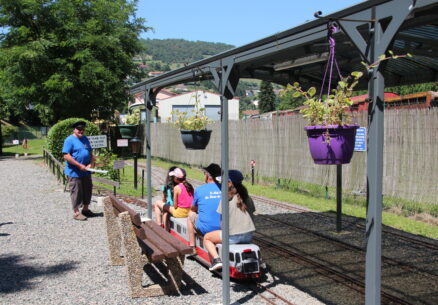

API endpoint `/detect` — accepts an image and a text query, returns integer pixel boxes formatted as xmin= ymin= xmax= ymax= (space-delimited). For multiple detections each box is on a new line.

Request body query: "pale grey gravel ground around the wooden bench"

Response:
xmin=0 ymin=159 xmax=321 ymax=305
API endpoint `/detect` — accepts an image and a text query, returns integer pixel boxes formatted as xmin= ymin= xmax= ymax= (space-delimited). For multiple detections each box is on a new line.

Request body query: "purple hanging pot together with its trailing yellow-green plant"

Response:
xmin=285 ymin=51 xmax=411 ymax=164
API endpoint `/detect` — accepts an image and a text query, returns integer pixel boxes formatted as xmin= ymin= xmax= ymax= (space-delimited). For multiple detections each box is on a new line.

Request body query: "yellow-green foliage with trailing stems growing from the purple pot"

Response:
xmin=284 ymin=51 xmax=412 ymax=126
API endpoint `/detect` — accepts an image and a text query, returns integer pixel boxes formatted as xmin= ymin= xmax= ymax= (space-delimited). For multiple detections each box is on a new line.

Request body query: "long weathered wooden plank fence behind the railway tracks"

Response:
xmin=151 ymin=108 xmax=438 ymax=203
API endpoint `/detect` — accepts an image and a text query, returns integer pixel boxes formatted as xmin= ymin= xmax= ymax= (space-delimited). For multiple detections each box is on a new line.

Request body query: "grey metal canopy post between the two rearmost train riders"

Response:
xmin=211 ymin=58 xmax=238 ymax=305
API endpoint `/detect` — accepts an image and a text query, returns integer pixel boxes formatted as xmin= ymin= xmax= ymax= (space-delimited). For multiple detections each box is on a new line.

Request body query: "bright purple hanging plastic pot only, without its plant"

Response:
xmin=304 ymin=124 xmax=359 ymax=164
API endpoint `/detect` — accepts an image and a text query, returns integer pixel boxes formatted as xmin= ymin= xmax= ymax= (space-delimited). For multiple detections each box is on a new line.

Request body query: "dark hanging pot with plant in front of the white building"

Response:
xmin=168 ymin=93 xmax=211 ymax=149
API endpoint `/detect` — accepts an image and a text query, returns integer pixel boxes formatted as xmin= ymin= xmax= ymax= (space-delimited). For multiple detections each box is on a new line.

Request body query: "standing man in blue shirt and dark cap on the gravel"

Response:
xmin=62 ymin=121 xmax=95 ymax=220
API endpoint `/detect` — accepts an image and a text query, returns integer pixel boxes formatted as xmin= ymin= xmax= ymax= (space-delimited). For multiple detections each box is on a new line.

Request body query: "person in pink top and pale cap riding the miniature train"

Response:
xmin=155 ymin=167 xmax=194 ymax=229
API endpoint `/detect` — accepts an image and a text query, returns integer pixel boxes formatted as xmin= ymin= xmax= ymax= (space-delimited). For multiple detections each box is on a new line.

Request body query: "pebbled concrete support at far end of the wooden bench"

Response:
xmin=103 ymin=197 xmax=124 ymax=266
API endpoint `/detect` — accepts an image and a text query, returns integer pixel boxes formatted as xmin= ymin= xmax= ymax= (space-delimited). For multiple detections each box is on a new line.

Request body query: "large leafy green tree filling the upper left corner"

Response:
xmin=0 ymin=0 xmax=149 ymax=124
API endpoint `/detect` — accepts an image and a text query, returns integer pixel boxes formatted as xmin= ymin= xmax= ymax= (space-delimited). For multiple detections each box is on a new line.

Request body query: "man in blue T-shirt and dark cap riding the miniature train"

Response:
xmin=187 ymin=163 xmax=221 ymax=254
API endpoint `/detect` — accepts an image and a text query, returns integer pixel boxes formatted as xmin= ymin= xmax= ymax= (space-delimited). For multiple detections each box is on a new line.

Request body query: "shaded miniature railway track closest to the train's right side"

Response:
xmin=254 ymin=237 xmax=412 ymax=305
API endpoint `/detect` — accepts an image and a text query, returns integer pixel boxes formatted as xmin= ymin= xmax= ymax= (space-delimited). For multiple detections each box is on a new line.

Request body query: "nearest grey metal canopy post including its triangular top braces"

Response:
xmin=339 ymin=0 xmax=415 ymax=305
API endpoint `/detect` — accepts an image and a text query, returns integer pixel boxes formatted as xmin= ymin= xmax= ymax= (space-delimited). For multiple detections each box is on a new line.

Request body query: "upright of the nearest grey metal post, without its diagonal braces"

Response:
xmin=365 ymin=8 xmax=385 ymax=305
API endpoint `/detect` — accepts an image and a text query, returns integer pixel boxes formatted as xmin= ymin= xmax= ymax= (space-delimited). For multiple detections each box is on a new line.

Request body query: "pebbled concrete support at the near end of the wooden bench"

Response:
xmin=119 ymin=212 xmax=184 ymax=298
